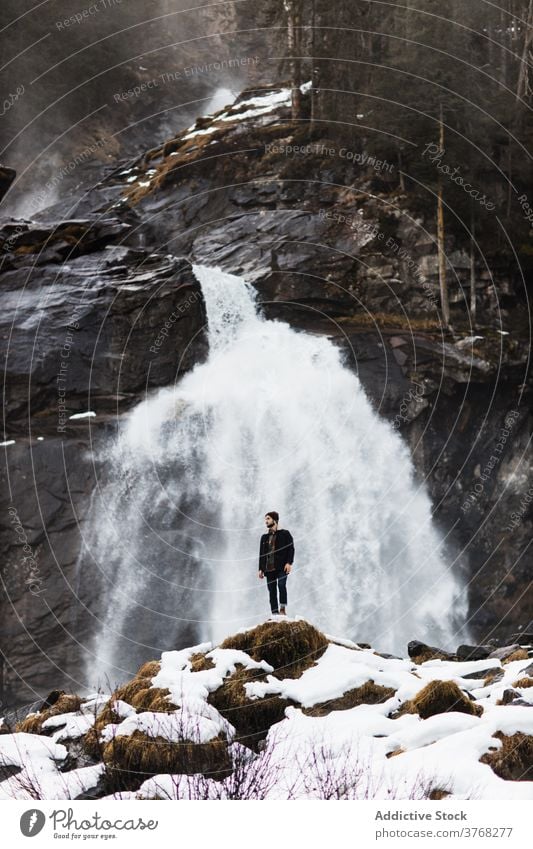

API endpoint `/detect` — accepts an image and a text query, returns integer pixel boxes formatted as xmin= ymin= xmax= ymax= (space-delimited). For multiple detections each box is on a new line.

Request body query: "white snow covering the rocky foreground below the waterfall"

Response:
xmin=0 ymin=620 xmax=533 ymax=799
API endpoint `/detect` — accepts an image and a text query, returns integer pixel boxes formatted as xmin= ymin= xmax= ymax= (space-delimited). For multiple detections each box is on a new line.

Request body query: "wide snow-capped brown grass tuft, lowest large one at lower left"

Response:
xmin=103 ymin=731 xmax=232 ymax=792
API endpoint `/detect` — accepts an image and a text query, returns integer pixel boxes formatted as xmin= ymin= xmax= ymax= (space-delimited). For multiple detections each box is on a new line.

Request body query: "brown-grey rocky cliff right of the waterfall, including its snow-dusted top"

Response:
xmin=117 ymin=84 xmax=533 ymax=637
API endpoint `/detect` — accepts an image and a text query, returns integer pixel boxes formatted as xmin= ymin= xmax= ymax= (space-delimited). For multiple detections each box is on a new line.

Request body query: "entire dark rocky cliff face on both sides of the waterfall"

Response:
xmin=2 ymin=84 xmax=533 ymax=701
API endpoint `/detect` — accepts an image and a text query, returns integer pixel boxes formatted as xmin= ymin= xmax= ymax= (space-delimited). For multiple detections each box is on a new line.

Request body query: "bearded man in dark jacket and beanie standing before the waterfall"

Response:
xmin=258 ymin=510 xmax=294 ymax=616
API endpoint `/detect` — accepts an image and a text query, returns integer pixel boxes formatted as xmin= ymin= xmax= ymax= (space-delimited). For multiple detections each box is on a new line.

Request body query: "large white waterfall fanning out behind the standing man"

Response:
xmin=85 ymin=266 xmax=466 ymax=677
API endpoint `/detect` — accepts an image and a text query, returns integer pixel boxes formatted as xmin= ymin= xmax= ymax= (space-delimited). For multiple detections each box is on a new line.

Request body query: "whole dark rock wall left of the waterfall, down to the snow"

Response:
xmin=0 ymin=218 xmax=205 ymax=704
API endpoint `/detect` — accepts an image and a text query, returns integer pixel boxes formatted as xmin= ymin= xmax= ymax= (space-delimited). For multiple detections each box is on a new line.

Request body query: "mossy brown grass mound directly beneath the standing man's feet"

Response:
xmin=220 ymin=620 xmax=328 ymax=678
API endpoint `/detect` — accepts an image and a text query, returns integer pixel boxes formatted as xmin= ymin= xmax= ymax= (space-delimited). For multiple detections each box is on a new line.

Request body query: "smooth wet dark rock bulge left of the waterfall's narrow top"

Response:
xmin=0 ymin=246 xmax=205 ymax=428
